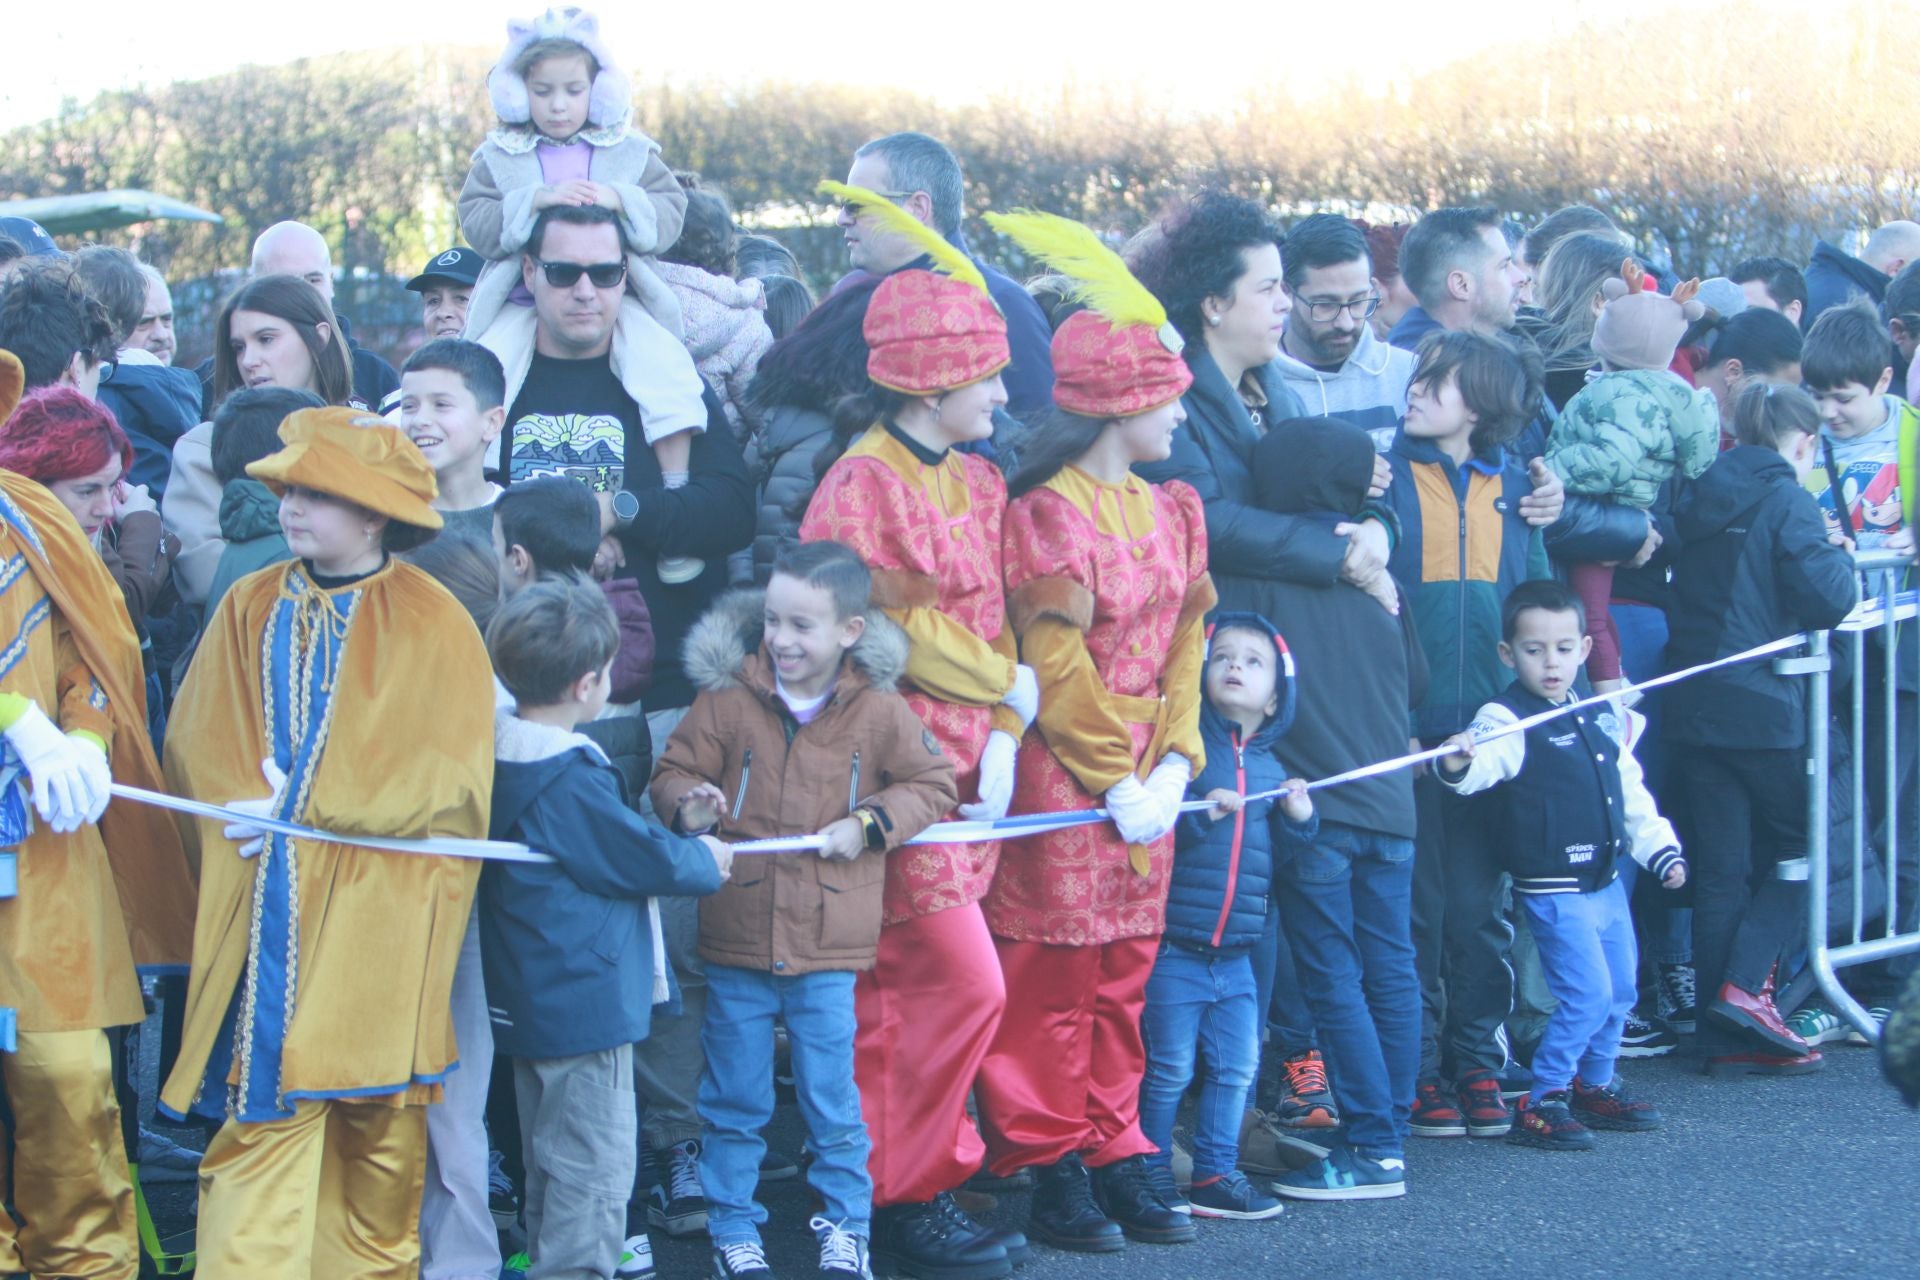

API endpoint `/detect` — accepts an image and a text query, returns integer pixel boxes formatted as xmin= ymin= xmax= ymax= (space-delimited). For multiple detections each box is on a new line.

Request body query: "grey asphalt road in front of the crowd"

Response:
xmin=139 ymin=1044 xmax=1920 ymax=1280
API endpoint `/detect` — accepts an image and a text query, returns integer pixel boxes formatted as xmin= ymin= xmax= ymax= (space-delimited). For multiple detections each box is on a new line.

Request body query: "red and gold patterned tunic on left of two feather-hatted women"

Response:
xmin=801 ymin=426 xmax=1020 ymax=925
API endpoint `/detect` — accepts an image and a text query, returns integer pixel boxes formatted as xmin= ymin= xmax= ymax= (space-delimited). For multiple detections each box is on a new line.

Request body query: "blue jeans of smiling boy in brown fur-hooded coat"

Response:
xmin=699 ymin=965 xmax=874 ymax=1245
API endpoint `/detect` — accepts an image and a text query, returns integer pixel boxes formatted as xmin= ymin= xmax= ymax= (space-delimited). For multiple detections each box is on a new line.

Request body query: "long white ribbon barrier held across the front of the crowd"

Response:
xmin=113 ymin=591 xmax=1920 ymax=864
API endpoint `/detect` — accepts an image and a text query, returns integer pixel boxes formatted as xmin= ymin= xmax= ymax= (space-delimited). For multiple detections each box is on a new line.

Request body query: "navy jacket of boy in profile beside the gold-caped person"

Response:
xmin=476 ymin=712 xmax=720 ymax=1057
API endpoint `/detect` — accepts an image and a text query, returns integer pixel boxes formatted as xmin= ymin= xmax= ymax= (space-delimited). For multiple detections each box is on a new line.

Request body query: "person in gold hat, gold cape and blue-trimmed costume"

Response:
xmin=161 ymin=407 xmax=493 ymax=1280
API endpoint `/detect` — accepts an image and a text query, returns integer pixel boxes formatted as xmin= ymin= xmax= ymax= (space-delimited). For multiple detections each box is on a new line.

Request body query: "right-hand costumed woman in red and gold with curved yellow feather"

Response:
xmin=979 ymin=213 xmax=1213 ymax=1253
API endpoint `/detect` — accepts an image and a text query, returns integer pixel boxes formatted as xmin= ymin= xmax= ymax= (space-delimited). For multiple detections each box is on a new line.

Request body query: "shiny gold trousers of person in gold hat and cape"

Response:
xmin=196 ymin=1100 xmax=426 ymax=1280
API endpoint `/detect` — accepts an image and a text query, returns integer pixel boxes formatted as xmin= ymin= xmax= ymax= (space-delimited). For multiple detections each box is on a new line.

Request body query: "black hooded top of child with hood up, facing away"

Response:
xmin=1250 ymin=418 xmax=1427 ymax=839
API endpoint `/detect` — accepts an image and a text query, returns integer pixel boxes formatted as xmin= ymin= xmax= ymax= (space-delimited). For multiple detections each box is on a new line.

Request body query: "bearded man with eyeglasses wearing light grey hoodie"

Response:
xmin=1273 ymin=213 xmax=1413 ymax=451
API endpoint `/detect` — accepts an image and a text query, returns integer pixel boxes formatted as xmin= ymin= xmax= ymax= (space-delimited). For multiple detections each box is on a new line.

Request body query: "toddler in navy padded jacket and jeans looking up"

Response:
xmin=1140 ymin=614 xmax=1319 ymax=1219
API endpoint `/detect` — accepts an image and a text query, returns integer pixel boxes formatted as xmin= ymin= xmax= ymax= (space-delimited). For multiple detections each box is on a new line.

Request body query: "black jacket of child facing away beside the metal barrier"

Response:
xmin=1663 ymin=445 xmax=1859 ymax=748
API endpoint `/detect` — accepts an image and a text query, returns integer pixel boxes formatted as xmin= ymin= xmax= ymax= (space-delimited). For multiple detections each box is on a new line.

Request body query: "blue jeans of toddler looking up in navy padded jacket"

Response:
xmin=1140 ymin=942 xmax=1260 ymax=1178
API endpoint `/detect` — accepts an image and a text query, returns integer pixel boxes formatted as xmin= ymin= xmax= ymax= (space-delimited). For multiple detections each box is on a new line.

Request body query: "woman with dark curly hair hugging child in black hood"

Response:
xmin=1131 ymin=192 xmax=1390 ymax=610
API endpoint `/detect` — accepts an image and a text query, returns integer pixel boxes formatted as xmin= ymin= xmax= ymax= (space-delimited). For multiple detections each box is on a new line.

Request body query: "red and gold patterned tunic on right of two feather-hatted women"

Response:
xmin=985 ymin=466 xmax=1213 ymax=946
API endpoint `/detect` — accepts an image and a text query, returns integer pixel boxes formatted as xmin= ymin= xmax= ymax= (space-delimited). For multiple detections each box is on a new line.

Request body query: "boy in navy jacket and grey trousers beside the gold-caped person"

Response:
xmin=480 ymin=578 xmax=733 ymax=1276
